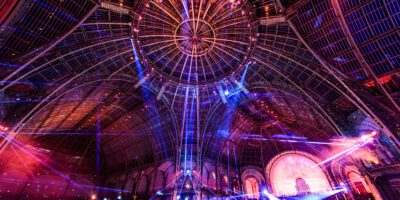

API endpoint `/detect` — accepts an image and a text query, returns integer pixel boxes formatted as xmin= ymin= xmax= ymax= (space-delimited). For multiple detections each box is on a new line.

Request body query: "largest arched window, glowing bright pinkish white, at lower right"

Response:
xmin=267 ymin=153 xmax=331 ymax=196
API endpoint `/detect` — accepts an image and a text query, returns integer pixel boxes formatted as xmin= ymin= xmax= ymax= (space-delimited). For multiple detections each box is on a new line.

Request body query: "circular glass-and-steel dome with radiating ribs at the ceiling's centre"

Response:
xmin=137 ymin=0 xmax=255 ymax=85
